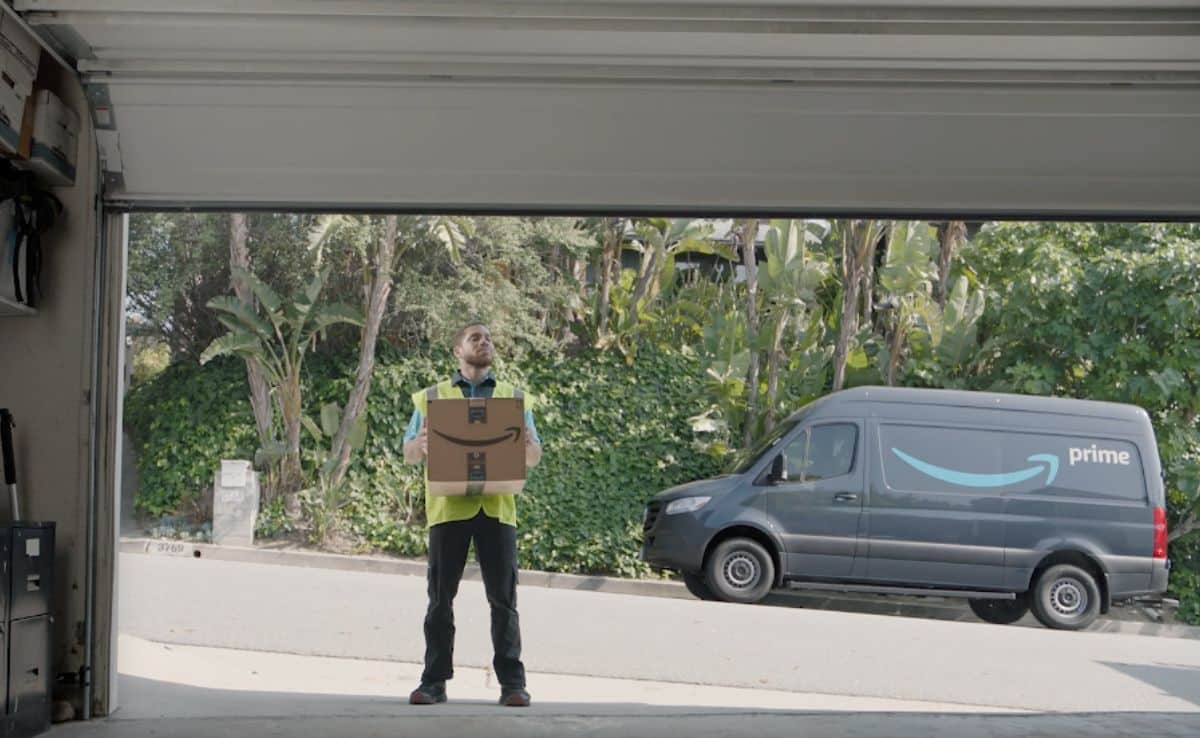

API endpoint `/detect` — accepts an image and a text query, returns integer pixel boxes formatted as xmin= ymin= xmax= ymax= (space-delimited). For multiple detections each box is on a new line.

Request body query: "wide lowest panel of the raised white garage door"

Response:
xmin=96 ymin=88 xmax=1200 ymax=212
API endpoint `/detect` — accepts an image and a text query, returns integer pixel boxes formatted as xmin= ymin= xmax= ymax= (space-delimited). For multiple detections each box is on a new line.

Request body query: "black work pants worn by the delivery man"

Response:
xmin=421 ymin=510 xmax=526 ymax=688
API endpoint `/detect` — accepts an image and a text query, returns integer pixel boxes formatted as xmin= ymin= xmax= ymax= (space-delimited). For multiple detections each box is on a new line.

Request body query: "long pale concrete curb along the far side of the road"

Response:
xmin=120 ymin=538 xmax=1200 ymax=640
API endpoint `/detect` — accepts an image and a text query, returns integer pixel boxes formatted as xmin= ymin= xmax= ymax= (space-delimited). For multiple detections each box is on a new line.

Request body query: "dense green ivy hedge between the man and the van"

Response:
xmin=518 ymin=353 xmax=720 ymax=575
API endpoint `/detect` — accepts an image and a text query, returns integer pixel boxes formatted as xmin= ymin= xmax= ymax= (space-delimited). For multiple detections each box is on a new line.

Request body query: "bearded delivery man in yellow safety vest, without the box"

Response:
xmin=404 ymin=323 xmax=541 ymax=707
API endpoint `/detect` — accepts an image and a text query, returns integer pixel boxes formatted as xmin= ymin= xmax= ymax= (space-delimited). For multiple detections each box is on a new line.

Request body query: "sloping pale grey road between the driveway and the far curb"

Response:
xmin=120 ymin=553 xmax=1200 ymax=714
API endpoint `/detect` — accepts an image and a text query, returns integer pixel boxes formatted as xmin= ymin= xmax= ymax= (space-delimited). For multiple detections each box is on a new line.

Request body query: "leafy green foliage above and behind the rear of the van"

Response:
xmin=964 ymin=223 xmax=1200 ymax=539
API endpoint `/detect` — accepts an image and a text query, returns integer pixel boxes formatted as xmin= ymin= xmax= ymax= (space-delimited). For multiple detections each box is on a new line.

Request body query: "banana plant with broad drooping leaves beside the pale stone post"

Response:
xmin=200 ymin=268 xmax=364 ymax=515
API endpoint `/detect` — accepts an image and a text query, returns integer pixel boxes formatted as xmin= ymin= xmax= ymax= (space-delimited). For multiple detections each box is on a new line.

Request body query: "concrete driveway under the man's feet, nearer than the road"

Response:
xmin=50 ymin=636 xmax=1200 ymax=738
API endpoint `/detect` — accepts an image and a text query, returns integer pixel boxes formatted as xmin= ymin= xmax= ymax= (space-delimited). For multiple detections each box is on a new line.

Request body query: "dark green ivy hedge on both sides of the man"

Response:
xmin=126 ymin=352 xmax=720 ymax=576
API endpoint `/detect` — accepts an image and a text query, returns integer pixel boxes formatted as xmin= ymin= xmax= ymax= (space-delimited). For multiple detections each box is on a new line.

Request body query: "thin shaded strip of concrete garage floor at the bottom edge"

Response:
xmin=50 ymin=702 xmax=1200 ymax=738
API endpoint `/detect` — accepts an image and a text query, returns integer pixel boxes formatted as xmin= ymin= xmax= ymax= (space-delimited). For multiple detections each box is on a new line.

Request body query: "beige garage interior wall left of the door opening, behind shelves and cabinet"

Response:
xmin=0 ymin=36 xmax=112 ymax=714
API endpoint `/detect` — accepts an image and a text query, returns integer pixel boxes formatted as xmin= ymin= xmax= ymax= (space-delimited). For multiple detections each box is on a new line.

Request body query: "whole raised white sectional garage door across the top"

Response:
xmin=14 ymin=0 xmax=1200 ymax=217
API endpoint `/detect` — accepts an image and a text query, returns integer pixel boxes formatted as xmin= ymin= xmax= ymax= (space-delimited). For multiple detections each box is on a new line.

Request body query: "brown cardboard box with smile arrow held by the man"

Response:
xmin=426 ymin=397 xmax=526 ymax=496
